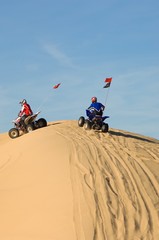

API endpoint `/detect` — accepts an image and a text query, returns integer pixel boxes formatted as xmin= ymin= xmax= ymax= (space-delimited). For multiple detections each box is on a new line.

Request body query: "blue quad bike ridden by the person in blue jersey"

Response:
xmin=78 ymin=109 xmax=109 ymax=132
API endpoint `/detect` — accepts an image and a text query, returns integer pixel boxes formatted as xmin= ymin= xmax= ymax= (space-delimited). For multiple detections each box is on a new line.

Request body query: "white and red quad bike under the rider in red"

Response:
xmin=8 ymin=112 xmax=47 ymax=138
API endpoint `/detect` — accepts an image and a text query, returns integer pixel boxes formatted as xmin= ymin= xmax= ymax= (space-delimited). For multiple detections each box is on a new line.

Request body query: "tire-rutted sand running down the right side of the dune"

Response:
xmin=52 ymin=124 xmax=159 ymax=240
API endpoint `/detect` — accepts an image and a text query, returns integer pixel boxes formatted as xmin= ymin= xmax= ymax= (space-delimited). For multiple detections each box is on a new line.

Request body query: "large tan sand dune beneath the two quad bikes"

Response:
xmin=0 ymin=121 xmax=159 ymax=240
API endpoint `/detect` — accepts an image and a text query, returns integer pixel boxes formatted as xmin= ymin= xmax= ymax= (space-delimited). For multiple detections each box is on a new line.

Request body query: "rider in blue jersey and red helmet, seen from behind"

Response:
xmin=88 ymin=97 xmax=105 ymax=116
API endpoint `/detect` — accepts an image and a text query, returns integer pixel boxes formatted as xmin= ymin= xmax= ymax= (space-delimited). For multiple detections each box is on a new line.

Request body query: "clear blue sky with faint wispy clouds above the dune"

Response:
xmin=0 ymin=0 xmax=159 ymax=139
